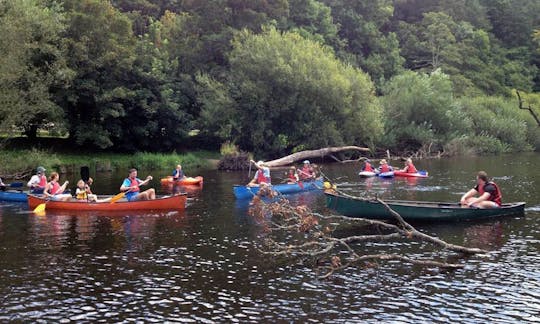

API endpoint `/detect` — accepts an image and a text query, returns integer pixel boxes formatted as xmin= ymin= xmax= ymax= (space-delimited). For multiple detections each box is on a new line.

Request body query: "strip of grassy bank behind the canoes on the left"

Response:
xmin=0 ymin=149 xmax=219 ymax=176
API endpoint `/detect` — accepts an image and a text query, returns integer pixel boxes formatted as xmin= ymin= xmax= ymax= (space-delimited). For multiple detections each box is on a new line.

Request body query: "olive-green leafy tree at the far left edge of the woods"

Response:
xmin=0 ymin=0 xmax=73 ymax=138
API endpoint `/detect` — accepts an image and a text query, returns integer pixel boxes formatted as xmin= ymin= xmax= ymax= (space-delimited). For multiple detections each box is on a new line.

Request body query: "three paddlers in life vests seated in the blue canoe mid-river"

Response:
xmin=247 ymin=160 xmax=317 ymax=187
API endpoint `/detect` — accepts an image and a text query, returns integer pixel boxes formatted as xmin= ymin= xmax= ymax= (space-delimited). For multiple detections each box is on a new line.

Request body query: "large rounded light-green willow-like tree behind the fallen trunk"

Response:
xmin=196 ymin=28 xmax=382 ymax=156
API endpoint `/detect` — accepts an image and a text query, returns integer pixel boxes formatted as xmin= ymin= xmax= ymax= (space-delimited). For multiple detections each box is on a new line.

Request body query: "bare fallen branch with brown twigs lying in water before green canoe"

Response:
xmin=249 ymin=192 xmax=488 ymax=278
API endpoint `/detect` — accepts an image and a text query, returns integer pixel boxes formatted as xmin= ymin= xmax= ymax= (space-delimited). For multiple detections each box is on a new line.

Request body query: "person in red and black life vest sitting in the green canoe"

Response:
xmin=460 ymin=171 xmax=502 ymax=208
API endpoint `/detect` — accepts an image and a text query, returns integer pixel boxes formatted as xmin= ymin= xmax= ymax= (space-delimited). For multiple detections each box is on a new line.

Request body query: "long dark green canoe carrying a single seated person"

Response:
xmin=325 ymin=192 xmax=525 ymax=222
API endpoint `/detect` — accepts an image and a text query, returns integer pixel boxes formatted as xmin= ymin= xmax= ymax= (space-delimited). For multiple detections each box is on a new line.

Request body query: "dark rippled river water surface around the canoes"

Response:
xmin=0 ymin=153 xmax=540 ymax=323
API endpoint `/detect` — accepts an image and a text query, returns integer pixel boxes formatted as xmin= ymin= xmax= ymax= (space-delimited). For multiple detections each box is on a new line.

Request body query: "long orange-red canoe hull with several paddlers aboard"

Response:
xmin=28 ymin=194 xmax=187 ymax=211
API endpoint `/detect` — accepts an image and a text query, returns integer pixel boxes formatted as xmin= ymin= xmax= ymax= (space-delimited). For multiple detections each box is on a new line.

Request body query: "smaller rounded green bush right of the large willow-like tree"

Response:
xmin=381 ymin=70 xmax=472 ymax=151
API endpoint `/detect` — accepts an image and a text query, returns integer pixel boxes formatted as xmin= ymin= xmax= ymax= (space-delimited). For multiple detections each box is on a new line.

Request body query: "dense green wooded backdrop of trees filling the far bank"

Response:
xmin=0 ymin=0 xmax=540 ymax=157
